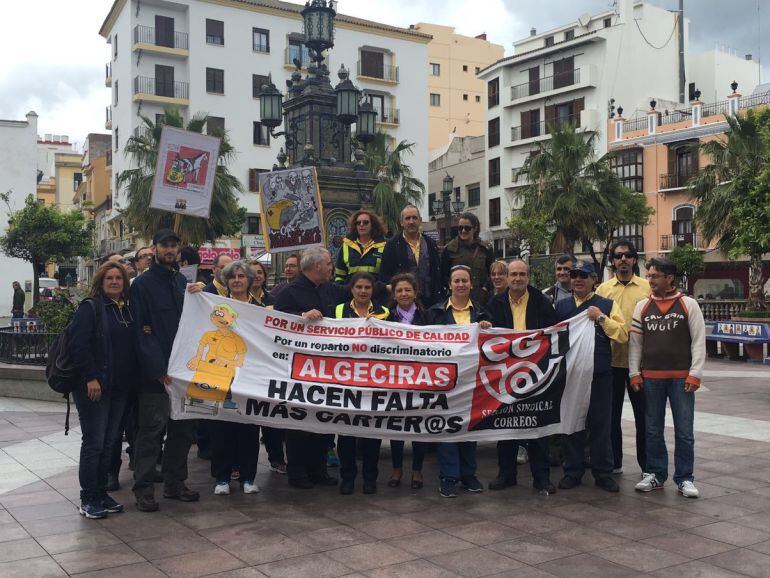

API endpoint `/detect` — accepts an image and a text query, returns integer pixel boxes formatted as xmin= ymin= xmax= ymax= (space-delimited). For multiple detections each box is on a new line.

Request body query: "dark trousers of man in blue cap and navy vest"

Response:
xmin=561 ymin=371 xmax=613 ymax=480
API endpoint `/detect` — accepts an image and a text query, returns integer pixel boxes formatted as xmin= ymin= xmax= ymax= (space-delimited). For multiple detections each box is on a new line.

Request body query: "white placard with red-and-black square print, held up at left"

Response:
xmin=150 ymin=126 xmax=221 ymax=219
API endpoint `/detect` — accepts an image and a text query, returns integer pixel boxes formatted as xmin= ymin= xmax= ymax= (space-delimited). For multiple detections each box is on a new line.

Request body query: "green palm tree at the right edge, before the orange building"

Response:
xmin=688 ymin=109 xmax=770 ymax=310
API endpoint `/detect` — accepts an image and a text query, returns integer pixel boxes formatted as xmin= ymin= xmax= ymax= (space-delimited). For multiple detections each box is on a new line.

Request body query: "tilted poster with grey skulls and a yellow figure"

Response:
xmin=259 ymin=167 xmax=323 ymax=253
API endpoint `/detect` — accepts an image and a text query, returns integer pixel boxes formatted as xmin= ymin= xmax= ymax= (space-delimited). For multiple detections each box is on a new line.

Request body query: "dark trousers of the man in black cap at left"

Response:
xmin=134 ymin=393 xmax=195 ymax=496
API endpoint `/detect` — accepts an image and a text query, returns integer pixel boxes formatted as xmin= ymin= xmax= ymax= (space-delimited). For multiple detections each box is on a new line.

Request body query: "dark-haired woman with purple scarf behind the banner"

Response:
xmin=388 ymin=273 xmax=429 ymax=490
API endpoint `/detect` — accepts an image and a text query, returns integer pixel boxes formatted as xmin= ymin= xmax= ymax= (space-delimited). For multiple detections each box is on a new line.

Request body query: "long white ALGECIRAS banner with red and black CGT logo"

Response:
xmin=168 ymin=293 xmax=595 ymax=441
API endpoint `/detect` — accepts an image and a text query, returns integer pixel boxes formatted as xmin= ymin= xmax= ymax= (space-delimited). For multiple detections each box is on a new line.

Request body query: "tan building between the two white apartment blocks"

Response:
xmin=412 ymin=22 xmax=505 ymax=150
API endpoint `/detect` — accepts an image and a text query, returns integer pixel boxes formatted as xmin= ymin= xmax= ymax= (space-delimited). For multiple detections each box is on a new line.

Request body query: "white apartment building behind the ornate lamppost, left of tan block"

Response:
xmin=100 ymin=0 xmax=431 ymax=245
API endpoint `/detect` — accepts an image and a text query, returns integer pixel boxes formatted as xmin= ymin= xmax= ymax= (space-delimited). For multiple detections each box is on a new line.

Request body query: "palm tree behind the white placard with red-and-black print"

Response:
xmin=117 ymin=108 xmax=246 ymax=246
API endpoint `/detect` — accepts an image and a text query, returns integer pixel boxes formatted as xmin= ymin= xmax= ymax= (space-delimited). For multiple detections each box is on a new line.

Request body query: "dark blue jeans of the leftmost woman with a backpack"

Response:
xmin=72 ymin=384 xmax=128 ymax=502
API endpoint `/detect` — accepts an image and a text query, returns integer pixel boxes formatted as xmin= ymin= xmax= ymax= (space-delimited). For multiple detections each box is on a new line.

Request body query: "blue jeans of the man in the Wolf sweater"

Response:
xmin=644 ymin=378 xmax=695 ymax=484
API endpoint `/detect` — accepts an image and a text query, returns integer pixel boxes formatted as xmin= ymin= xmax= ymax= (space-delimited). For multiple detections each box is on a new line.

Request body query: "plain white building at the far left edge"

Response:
xmin=0 ymin=111 xmax=38 ymax=317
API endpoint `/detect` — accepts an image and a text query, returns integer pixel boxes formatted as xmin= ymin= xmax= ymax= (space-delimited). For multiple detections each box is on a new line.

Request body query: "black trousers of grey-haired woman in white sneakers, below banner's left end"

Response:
xmin=209 ymin=420 xmax=259 ymax=483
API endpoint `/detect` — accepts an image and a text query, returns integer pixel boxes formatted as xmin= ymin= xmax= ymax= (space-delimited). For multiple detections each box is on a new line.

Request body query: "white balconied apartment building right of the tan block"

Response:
xmin=479 ymin=0 xmax=758 ymax=253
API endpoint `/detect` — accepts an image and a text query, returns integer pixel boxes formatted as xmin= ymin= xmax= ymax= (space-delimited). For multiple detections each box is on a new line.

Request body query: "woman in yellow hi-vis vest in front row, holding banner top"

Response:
xmin=334 ymin=272 xmax=390 ymax=495
